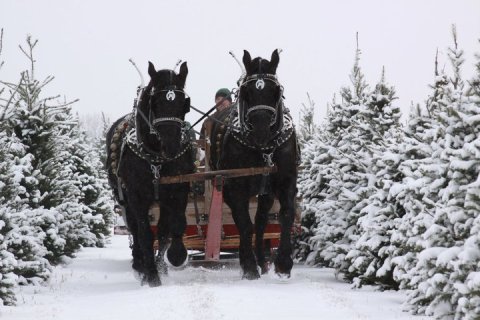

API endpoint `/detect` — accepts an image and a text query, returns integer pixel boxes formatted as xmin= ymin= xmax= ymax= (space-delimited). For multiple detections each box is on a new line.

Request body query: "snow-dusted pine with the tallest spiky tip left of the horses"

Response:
xmin=3 ymin=37 xmax=108 ymax=263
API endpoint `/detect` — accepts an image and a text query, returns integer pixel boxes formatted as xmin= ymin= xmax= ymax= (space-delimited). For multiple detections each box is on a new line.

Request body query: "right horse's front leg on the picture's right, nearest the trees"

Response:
xmin=275 ymin=183 xmax=296 ymax=277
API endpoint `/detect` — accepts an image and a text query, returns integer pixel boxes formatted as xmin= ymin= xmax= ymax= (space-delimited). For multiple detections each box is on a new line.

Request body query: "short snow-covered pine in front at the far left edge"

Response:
xmin=0 ymin=129 xmax=50 ymax=284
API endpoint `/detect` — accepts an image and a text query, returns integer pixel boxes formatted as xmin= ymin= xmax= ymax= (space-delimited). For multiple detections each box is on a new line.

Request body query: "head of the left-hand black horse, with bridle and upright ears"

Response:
xmin=136 ymin=62 xmax=190 ymax=159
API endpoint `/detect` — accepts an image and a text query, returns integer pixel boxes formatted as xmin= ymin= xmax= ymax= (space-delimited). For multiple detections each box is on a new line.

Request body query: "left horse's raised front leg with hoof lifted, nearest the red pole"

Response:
xmin=167 ymin=188 xmax=188 ymax=267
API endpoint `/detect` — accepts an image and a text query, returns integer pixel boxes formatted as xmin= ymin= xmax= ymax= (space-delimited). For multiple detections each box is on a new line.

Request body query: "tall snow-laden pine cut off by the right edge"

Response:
xmin=402 ymin=27 xmax=480 ymax=319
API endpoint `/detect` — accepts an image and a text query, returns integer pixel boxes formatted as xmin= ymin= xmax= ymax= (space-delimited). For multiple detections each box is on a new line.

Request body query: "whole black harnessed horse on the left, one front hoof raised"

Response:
xmin=107 ymin=62 xmax=194 ymax=286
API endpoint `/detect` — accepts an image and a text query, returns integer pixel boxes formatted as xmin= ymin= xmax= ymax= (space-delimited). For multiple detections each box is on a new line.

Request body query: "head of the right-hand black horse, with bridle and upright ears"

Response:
xmin=239 ymin=50 xmax=283 ymax=147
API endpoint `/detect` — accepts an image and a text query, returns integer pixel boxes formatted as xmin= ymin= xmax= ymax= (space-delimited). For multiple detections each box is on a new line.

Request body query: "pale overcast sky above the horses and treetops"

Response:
xmin=0 ymin=0 xmax=480 ymax=129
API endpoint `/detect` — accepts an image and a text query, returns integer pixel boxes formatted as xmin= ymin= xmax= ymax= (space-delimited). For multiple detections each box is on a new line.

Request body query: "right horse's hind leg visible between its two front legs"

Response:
xmin=255 ymin=194 xmax=274 ymax=274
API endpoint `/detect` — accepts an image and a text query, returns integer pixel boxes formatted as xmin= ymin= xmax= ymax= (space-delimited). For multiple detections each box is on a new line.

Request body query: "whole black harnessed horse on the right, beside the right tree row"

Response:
xmin=210 ymin=50 xmax=299 ymax=279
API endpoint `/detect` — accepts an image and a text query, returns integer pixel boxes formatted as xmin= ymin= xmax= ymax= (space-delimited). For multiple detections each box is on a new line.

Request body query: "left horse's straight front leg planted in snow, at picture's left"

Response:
xmin=129 ymin=199 xmax=161 ymax=287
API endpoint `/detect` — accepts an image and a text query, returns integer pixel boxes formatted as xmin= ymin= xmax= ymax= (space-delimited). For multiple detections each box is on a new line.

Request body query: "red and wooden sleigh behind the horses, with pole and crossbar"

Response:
xmin=149 ymin=136 xmax=301 ymax=261
